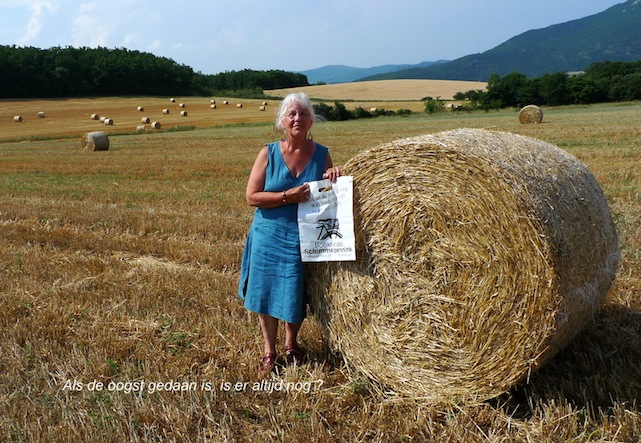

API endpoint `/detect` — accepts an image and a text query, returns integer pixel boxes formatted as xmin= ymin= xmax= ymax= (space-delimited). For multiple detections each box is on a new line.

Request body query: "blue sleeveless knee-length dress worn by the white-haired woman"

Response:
xmin=238 ymin=142 xmax=328 ymax=323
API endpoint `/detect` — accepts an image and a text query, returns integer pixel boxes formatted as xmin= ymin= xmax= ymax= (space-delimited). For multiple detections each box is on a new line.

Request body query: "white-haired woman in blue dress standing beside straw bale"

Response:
xmin=238 ymin=93 xmax=340 ymax=373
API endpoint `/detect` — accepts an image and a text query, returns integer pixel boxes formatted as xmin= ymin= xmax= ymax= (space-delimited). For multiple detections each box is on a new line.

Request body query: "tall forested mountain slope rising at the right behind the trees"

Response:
xmin=367 ymin=0 xmax=641 ymax=81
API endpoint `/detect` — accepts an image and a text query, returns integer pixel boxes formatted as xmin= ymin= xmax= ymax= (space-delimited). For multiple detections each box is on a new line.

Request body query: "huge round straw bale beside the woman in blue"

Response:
xmin=307 ymin=129 xmax=619 ymax=402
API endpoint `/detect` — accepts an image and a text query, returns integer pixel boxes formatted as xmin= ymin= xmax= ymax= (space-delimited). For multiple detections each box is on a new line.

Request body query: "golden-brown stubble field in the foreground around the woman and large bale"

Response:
xmin=0 ymin=103 xmax=641 ymax=442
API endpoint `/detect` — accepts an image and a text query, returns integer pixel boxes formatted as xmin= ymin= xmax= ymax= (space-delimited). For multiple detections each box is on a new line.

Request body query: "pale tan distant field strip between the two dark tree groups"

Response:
xmin=265 ymin=80 xmax=487 ymax=101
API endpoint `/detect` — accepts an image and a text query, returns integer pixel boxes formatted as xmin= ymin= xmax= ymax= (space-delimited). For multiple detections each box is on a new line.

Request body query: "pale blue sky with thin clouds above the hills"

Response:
xmin=0 ymin=0 xmax=624 ymax=74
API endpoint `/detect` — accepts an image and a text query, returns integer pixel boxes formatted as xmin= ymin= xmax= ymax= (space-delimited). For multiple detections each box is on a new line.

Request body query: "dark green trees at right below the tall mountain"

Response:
xmin=454 ymin=61 xmax=641 ymax=109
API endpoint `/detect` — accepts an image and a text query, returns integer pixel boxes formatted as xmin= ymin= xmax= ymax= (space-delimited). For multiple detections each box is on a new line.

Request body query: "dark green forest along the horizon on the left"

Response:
xmin=0 ymin=46 xmax=308 ymax=98
